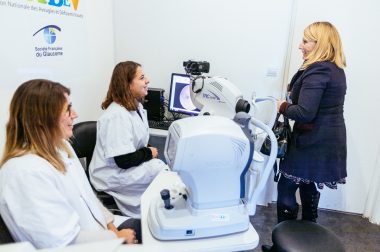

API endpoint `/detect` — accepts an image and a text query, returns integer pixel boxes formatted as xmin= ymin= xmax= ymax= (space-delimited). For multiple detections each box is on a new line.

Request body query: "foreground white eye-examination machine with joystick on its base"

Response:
xmin=148 ymin=116 xmax=250 ymax=240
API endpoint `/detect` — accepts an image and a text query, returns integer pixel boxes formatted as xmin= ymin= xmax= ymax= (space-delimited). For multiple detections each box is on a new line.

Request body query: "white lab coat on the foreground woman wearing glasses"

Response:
xmin=0 ymin=142 xmax=121 ymax=248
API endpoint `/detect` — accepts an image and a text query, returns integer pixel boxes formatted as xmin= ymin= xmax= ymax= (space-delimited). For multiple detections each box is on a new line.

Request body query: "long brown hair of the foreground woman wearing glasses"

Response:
xmin=0 ymin=79 xmax=71 ymax=172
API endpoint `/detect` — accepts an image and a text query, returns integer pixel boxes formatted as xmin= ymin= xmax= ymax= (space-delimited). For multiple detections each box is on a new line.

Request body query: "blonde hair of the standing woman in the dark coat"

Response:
xmin=301 ymin=22 xmax=346 ymax=69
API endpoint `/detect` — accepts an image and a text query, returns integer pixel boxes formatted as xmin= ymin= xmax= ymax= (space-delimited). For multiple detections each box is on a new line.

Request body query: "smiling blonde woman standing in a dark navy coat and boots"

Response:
xmin=277 ymin=22 xmax=347 ymax=222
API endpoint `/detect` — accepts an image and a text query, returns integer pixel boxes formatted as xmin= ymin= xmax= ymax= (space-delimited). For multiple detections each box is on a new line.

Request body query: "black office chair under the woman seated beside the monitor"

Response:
xmin=70 ymin=121 xmax=120 ymax=213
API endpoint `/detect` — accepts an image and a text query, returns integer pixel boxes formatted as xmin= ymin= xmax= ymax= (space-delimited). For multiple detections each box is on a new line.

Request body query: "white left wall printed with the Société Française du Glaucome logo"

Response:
xmin=0 ymin=0 xmax=114 ymax=153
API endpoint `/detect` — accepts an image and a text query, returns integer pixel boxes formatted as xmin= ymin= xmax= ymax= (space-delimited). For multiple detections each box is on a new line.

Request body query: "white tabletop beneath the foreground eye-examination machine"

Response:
xmin=117 ymin=171 xmax=259 ymax=252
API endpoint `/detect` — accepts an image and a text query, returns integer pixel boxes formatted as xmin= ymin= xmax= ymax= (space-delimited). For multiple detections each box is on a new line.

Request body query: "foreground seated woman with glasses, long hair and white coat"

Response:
xmin=0 ymin=79 xmax=141 ymax=248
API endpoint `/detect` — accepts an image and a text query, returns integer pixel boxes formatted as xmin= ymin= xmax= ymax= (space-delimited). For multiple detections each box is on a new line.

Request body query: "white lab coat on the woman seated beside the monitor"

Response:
xmin=89 ymin=103 xmax=167 ymax=218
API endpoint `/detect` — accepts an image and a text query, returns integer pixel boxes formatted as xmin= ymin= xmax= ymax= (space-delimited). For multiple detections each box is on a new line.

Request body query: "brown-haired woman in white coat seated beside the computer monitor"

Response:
xmin=89 ymin=61 xmax=167 ymax=218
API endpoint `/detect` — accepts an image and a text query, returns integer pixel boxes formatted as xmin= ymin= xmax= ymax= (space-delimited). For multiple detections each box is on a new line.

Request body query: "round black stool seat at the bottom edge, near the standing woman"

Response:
xmin=271 ymin=220 xmax=345 ymax=252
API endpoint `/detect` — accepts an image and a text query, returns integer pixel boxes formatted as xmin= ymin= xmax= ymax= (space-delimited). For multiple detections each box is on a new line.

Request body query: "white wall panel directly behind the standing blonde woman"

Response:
xmin=289 ymin=0 xmax=380 ymax=213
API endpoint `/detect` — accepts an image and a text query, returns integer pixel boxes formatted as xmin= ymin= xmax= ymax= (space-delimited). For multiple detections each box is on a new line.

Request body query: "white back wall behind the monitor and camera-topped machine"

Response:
xmin=114 ymin=0 xmax=292 ymax=108
